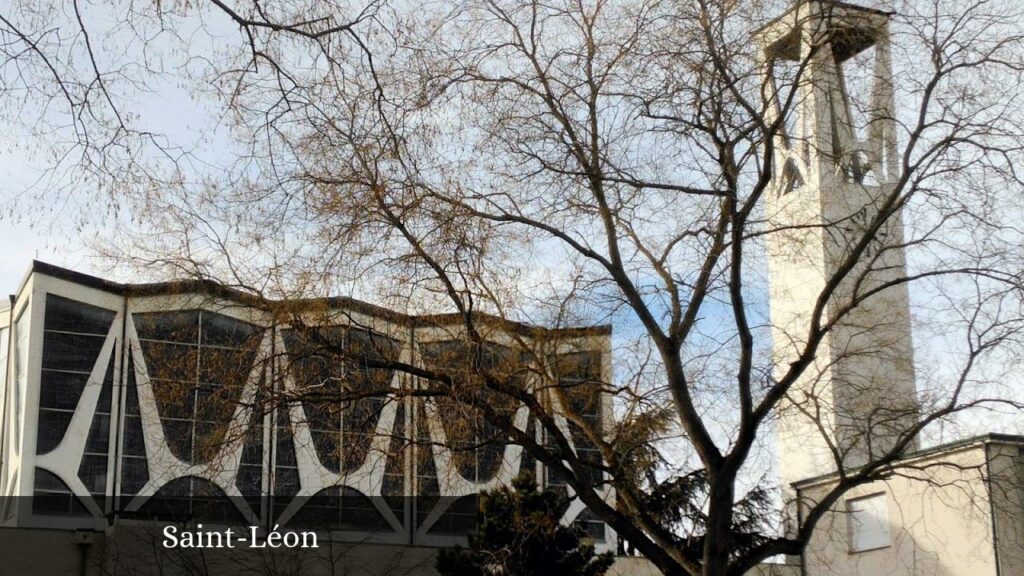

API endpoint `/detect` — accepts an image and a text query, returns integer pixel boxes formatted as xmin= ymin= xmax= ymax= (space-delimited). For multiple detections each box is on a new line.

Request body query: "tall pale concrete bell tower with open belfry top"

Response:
xmin=756 ymin=0 xmax=918 ymax=486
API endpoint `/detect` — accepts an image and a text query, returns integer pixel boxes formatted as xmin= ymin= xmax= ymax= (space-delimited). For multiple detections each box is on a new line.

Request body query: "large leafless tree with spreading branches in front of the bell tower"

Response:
xmin=2 ymin=0 xmax=1024 ymax=576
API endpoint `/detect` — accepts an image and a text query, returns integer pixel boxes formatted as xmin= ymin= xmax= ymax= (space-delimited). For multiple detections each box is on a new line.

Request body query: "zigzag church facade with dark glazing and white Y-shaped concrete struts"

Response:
xmin=0 ymin=266 xmax=615 ymax=549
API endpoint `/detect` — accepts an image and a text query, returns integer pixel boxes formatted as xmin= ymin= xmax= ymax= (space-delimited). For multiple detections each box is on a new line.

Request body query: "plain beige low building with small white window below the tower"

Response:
xmin=798 ymin=442 xmax=1024 ymax=576
